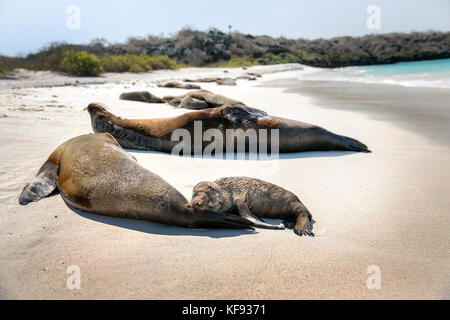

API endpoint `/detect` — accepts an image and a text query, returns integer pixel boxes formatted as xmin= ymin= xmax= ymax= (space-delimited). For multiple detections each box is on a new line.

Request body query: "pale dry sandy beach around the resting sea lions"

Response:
xmin=0 ymin=64 xmax=450 ymax=299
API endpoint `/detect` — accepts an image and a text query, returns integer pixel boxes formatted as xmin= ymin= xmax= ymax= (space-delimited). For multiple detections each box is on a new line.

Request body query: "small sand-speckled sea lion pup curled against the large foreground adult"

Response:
xmin=191 ymin=177 xmax=314 ymax=236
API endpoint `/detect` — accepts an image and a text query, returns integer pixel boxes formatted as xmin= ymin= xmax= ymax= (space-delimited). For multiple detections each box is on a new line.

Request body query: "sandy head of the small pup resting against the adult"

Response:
xmin=191 ymin=181 xmax=225 ymax=213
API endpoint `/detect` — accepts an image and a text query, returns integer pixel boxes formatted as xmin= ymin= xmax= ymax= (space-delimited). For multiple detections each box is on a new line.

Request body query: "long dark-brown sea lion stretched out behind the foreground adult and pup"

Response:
xmin=86 ymin=103 xmax=370 ymax=155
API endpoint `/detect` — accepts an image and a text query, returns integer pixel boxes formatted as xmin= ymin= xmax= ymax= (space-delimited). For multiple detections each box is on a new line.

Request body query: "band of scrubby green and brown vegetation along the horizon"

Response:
xmin=0 ymin=28 xmax=450 ymax=76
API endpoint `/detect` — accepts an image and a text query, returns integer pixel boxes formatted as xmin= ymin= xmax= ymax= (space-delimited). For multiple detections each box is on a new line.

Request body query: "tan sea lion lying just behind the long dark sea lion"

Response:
xmin=163 ymin=90 xmax=243 ymax=110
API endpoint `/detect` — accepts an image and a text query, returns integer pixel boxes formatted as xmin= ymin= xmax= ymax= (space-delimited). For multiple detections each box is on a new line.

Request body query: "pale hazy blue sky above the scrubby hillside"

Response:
xmin=0 ymin=0 xmax=450 ymax=56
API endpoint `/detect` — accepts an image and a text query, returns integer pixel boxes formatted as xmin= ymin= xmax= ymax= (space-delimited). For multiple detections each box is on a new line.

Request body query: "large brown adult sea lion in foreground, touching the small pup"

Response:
xmin=19 ymin=133 xmax=252 ymax=228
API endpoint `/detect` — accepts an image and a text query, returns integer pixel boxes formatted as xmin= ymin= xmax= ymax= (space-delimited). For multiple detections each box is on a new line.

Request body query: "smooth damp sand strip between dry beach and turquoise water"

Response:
xmin=261 ymin=78 xmax=450 ymax=148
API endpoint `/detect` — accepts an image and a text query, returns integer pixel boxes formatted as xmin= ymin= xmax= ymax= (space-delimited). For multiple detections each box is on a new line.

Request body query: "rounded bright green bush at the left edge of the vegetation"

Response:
xmin=59 ymin=50 xmax=102 ymax=77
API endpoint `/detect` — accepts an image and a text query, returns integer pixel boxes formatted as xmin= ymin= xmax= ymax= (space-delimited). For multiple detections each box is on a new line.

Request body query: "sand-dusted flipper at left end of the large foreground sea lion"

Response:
xmin=19 ymin=161 xmax=59 ymax=205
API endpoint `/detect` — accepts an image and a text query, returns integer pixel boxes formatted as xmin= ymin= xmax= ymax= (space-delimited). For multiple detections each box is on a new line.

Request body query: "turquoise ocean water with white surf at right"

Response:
xmin=300 ymin=59 xmax=450 ymax=88
